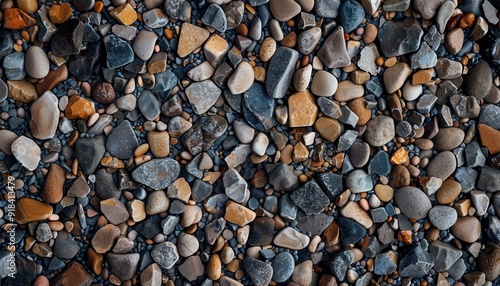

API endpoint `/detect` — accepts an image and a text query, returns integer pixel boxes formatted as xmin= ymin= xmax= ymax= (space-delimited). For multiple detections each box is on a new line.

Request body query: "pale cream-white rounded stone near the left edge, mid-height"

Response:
xmin=10 ymin=136 xmax=41 ymax=171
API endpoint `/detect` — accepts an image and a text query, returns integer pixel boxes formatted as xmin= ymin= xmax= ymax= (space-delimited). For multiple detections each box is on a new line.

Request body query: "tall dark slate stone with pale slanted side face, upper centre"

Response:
xmin=266 ymin=47 xmax=299 ymax=98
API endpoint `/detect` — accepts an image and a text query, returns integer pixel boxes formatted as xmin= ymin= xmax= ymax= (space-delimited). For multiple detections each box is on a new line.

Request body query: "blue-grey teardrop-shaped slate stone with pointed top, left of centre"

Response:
xmin=106 ymin=120 xmax=139 ymax=160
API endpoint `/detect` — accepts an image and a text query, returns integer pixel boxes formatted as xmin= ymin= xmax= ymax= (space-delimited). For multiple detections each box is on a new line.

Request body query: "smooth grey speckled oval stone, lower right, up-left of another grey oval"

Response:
xmin=394 ymin=186 xmax=432 ymax=220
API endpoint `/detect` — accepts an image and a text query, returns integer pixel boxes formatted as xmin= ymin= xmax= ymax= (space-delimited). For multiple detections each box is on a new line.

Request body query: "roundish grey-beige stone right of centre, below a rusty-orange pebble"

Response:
xmin=364 ymin=115 xmax=396 ymax=147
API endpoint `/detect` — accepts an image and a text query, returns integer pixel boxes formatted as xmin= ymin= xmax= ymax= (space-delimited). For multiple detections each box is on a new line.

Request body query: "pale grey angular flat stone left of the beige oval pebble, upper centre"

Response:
xmin=186 ymin=80 xmax=221 ymax=114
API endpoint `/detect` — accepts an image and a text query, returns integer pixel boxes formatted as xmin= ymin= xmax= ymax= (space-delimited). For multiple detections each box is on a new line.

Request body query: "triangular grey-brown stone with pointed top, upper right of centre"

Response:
xmin=317 ymin=26 xmax=351 ymax=68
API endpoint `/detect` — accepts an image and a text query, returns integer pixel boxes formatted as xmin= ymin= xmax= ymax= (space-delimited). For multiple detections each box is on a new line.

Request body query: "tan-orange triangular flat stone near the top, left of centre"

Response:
xmin=178 ymin=22 xmax=210 ymax=58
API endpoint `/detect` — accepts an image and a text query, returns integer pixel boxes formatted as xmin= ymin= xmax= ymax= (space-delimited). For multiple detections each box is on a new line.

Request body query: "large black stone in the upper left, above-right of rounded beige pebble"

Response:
xmin=50 ymin=18 xmax=84 ymax=57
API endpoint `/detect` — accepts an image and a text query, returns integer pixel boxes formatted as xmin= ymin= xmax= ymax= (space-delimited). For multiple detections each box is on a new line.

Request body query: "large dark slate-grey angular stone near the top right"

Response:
xmin=378 ymin=18 xmax=424 ymax=57
